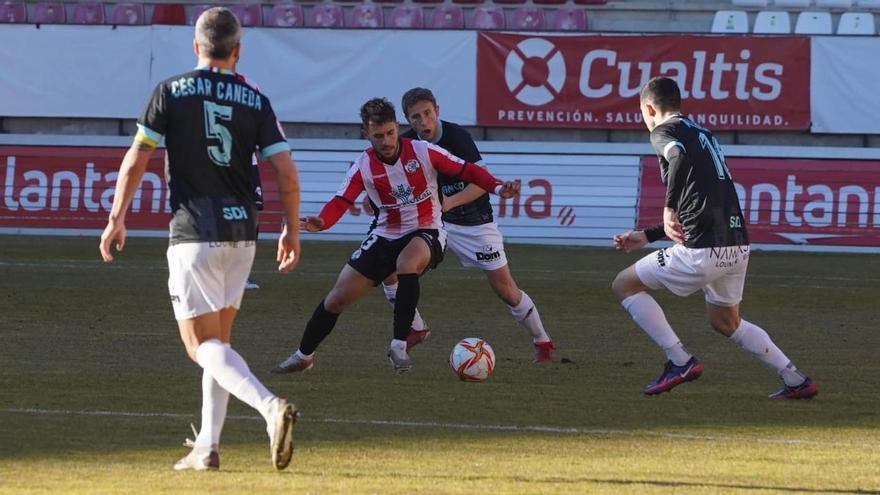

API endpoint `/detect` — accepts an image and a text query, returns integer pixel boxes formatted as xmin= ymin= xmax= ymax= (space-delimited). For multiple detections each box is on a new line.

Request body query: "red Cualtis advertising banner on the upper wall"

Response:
xmin=477 ymin=33 xmax=810 ymax=130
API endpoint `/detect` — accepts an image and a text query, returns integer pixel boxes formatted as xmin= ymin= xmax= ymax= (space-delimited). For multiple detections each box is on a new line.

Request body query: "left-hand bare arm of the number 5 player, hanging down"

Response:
xmin=99 ymin=141 xmax=155 ymax=262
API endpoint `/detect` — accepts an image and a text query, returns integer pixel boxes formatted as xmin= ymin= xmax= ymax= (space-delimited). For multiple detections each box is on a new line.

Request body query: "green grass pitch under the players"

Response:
xmin=0 ymin=236 xmax=880 ymax=495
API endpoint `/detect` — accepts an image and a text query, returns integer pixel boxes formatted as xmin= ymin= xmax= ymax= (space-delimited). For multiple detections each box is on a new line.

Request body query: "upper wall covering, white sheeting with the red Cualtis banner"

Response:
xmin=0 ymin=25 xmax=880 ymax=135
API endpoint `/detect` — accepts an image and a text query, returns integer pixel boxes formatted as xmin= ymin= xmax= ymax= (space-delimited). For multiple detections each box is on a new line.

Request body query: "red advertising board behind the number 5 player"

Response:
xmin=0 ymin=146 xmax=281 ymax=232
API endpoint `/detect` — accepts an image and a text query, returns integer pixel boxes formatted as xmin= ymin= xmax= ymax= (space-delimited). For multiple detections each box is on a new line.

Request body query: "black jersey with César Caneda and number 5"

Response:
xmin=135 ymin=68 xmax=290 ymax=244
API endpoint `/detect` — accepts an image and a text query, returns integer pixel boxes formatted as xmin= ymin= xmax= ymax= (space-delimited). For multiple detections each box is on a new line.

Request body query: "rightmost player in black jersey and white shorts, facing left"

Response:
xmin=612 ymin=77 xmax=818 ymax=399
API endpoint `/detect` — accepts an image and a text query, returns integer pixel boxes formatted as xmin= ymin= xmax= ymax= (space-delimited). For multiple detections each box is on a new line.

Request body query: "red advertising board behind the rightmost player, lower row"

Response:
xmin=638 ymin=157 xmax=880 ymax=247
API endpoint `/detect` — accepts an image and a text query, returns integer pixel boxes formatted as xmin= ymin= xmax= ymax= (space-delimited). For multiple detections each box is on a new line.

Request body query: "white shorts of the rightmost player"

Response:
xmin=636 ymin=244 xmax=749 ymax=306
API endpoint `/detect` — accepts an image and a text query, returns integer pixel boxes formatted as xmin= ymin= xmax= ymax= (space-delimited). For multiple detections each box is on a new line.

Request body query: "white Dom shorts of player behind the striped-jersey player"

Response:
xmin=443 ymin=222 xmax=507 ymax=270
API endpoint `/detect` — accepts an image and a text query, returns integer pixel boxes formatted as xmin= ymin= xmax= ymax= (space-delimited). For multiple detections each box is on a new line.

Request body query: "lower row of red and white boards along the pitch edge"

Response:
xmin=0 ymin=135 xmax=880 ymax=252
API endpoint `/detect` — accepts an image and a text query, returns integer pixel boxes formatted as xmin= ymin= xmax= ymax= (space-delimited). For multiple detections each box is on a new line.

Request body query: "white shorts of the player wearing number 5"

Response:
xmin=168 ymin=241 xmax=256 ymax=320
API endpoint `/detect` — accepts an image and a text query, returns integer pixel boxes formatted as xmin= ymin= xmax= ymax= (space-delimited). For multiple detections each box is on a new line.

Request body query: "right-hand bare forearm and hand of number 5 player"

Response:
xmin=269 ymin=151 xmax=301 ymax=273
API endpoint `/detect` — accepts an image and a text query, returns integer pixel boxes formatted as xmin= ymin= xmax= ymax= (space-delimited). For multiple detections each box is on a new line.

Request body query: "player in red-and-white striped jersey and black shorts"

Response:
xmin=272 ymin=98 xmax=519 ymax=373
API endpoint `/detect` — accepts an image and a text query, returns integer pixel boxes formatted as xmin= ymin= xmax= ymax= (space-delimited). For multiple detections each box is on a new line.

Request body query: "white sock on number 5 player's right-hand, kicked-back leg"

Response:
xmin=196 ymin=339 xmax=276 ymax=422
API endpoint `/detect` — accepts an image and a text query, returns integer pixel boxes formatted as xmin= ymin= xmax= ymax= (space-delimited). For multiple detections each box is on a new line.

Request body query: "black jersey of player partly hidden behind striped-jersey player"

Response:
xmin=403 ymin=120 xmax=494 ymax=225
